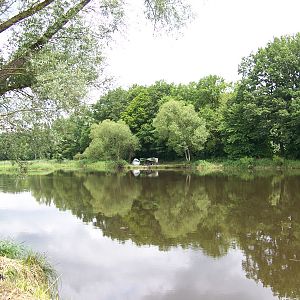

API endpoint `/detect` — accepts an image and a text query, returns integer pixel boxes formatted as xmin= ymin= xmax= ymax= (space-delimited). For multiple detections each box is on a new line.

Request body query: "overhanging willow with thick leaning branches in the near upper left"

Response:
xmin=0 ymin=0 xmax=190 ymax=130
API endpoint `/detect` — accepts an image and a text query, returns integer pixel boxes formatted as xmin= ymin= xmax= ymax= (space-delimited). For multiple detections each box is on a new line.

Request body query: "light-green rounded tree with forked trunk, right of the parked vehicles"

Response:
xmin=153 ymin=99 xmax=208 ymax=161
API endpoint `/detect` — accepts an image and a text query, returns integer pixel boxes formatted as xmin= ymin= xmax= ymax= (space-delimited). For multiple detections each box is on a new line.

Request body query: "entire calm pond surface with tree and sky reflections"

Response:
xmin=0 ymin=172 xmax=300 ymax=300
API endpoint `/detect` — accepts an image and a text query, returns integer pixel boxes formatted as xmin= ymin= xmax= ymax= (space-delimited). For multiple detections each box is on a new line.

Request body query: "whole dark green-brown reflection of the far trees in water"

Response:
xmin=0 ymin=172 xmax=300 ymax=298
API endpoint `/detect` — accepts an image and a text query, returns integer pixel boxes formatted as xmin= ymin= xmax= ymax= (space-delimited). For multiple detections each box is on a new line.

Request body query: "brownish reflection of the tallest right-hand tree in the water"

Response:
xmin=232 ymin=177 xmax=300 ymax=299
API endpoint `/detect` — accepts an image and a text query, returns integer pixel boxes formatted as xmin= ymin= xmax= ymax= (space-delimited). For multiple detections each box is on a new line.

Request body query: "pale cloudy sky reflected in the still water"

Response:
xmin=0 ymin=193 xmax=274 ymax=300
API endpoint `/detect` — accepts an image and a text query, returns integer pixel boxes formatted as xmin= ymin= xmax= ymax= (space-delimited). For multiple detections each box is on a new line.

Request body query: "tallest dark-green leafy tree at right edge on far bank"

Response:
xmin=225 ymin=34 xmax=300 ymax=158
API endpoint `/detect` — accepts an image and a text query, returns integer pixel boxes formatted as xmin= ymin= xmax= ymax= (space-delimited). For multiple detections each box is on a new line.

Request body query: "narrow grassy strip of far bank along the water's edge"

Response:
xmin=0 ymin=157 xmax=300 ymax=175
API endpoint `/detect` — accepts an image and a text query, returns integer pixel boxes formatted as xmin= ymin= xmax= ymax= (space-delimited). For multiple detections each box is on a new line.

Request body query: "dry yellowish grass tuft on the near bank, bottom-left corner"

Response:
xmin=0 ymin=240 xmax=58 ymax=300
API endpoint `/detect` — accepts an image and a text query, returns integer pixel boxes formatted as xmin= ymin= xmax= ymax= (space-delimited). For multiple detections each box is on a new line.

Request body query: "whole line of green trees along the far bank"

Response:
xmin=0 ymin=34 xmax=300 ymax=160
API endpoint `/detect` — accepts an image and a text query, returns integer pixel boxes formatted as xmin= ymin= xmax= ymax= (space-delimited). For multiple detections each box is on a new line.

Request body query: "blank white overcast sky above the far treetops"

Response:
xmin=104 ymin=0 xmax=300 ymax=87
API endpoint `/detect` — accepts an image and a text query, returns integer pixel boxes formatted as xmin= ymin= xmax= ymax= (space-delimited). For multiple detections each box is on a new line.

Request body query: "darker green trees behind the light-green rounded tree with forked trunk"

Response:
xmin=93 ymin=76 xmax=230 ymax=160
